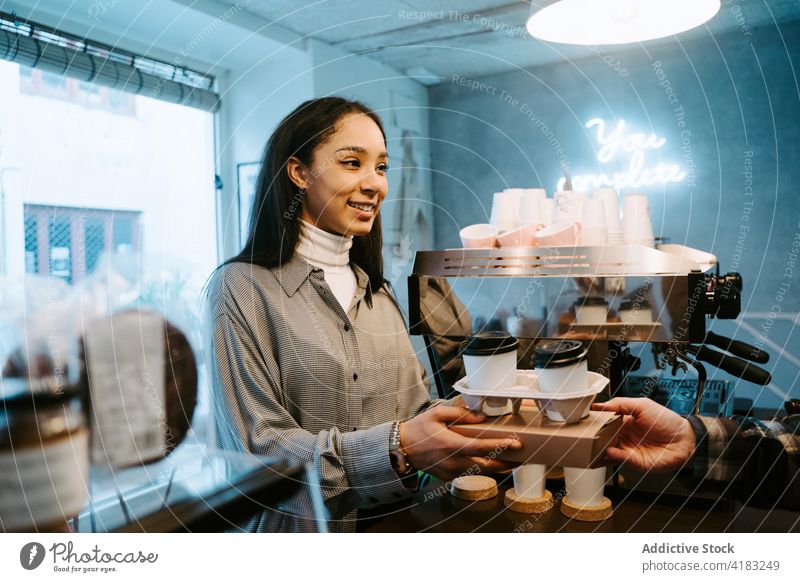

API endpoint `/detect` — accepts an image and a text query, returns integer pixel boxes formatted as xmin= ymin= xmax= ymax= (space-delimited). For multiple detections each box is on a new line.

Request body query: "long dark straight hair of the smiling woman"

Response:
xmin=223 ymin=97 xmax=388 ymax=307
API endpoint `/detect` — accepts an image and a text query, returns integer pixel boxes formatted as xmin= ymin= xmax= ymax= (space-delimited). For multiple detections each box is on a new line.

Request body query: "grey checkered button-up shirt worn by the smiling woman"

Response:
xmin=203 ymin=255 xmax=433 ymax=531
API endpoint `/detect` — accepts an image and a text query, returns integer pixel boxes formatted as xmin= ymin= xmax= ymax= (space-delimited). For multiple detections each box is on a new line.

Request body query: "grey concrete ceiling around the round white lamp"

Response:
xmin=215 ymin=0 xmax=800 ymax=82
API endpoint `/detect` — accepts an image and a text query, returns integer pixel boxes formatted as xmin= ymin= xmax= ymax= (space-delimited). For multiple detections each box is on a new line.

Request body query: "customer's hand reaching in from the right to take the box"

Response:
xmin=592 ymin=398 xmax=695 ymax=471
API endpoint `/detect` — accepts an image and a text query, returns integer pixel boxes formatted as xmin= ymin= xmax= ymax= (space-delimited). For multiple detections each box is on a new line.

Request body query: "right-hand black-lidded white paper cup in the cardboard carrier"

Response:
xmin=533 ymin=340 xmax=589 ymax=393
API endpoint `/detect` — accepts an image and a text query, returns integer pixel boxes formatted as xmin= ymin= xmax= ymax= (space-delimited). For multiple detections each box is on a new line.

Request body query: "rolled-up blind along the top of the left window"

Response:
xmin=0 ymin=13 xmax=220 ymax=112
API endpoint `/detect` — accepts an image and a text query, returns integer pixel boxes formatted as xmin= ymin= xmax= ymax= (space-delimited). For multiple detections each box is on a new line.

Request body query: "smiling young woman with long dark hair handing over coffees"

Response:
xmin=209 ymin=97 xmax=521 ymax=531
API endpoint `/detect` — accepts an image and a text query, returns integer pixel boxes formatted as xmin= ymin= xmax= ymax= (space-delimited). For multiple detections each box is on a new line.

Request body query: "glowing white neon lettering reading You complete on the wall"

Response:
xmin=556 ymin=117 xmax=686 ymax=191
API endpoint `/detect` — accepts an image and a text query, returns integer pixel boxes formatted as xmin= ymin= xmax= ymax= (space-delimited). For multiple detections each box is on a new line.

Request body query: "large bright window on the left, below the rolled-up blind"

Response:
xmin=0 ymin=60 xmax=217 ymax=428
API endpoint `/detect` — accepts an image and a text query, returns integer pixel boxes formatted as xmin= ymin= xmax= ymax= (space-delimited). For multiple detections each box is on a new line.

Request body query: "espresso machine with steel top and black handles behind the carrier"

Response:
xmin=408 ymin=244 xmax=771 ymax=414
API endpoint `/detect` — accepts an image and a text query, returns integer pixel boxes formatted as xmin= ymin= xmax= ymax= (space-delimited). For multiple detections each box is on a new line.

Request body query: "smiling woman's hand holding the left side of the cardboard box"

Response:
xmin=400 ymin=405 xmax=522 ymax=480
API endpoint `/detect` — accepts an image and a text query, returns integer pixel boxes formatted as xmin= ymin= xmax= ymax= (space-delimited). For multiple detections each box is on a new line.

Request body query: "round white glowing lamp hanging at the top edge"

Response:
xmin=527 ymin=0 xmax=720 ymax=45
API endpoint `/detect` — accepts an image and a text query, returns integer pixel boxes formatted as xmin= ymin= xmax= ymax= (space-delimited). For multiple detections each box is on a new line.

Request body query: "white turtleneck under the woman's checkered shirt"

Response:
xmin=296 ymin=220 xmax=357 ymax=313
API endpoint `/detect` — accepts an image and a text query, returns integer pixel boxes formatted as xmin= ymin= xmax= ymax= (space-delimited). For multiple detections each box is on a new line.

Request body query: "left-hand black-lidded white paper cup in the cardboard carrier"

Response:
xmin=461 ymin=331 xmax=519 ymax=392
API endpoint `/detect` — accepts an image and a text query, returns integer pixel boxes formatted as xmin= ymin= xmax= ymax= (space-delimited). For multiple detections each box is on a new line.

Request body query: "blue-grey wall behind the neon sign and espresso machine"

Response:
xmin=430 ymin=22 xmax=800 ymax=406
